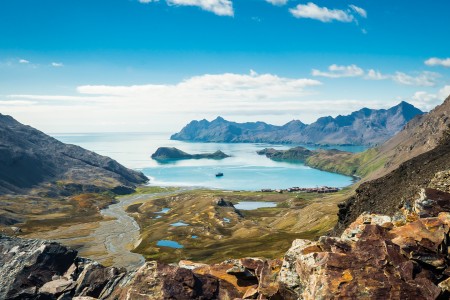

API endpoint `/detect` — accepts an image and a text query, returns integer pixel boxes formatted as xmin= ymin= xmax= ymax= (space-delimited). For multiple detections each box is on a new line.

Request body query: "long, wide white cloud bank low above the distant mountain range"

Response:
xmin=77 ymin=70 xmax=321 ymax=98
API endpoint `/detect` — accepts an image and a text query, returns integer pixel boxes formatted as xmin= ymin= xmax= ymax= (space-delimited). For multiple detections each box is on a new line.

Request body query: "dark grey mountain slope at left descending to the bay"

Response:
xmin=0 ymin=114 xmax=147 ymax=195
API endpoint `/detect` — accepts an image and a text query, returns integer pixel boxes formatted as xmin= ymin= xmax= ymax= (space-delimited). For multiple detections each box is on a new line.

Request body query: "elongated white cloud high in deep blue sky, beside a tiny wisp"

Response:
xmin=289 ymin=2 xmax=354 ymax=23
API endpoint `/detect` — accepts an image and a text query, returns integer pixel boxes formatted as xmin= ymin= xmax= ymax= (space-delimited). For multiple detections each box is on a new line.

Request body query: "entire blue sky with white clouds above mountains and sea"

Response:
xmin=0 ymin=0 xmax=450 ymax=132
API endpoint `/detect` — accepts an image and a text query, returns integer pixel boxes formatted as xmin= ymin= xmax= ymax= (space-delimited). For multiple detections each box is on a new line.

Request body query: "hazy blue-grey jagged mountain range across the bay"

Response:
xmin=171 ymin=102 xmax=423 ymax=146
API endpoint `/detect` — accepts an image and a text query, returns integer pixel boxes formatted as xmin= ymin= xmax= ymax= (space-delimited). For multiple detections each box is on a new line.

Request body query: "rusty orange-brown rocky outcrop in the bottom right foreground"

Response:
xmin=279 ymin=213 xmax=450 ymax=299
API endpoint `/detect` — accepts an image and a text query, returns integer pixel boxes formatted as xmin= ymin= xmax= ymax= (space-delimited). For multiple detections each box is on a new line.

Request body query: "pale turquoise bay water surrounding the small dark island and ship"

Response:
xmin=53 ymin=133 xmax=365 ymax=190
